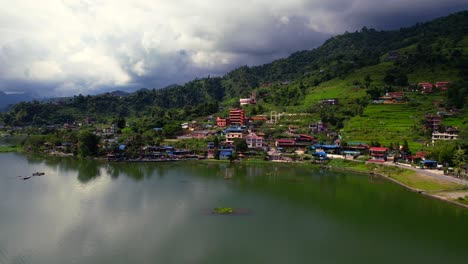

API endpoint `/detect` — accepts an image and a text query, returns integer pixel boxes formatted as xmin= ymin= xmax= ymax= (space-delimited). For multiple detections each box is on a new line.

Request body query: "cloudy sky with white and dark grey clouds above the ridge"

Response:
xmin=0 ymin=0 xmax=468 ymax=97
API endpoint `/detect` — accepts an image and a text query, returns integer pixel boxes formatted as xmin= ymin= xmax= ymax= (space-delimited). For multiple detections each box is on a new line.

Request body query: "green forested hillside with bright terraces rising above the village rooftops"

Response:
xmin=1 ymin=11 xmax=468 ymax=129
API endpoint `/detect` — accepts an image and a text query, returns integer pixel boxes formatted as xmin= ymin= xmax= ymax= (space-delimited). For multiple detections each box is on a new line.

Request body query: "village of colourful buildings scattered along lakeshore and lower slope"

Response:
xmin=0 ymin=82 xmax=468 ymax=179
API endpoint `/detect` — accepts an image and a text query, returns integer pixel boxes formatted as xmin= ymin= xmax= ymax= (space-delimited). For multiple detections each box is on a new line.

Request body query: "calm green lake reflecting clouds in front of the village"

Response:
xmin=0 ymin=153 xmax=468 ymax=264
